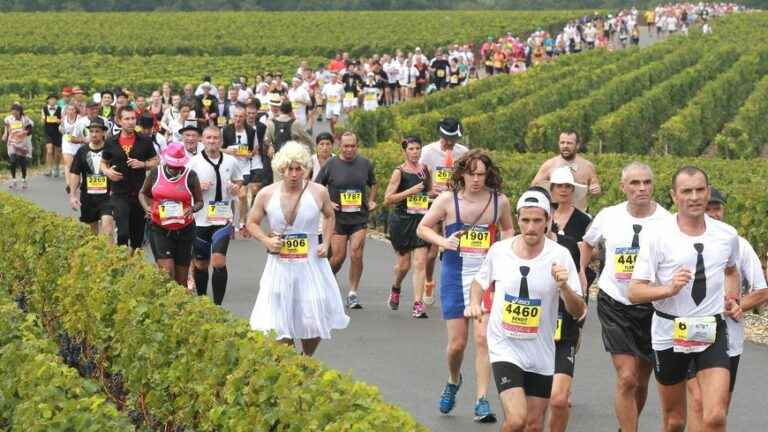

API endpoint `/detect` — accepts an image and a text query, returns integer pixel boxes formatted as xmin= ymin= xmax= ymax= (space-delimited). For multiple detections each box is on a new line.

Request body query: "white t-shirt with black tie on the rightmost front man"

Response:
xmin=632 ymin=214 xmax=739 ymax=351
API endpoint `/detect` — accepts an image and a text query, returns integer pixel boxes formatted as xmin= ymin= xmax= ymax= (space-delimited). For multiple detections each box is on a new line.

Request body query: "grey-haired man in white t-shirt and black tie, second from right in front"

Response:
xmin=581 ymin=162 xmax=669 ymax=432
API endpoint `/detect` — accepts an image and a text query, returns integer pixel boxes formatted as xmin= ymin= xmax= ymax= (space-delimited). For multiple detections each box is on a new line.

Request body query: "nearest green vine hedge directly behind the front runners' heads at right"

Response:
xmin=364 ymin=142 xmax=768 ymax=256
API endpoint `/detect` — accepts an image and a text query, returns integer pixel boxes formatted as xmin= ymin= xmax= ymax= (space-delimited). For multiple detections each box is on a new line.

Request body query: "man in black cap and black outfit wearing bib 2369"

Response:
xmin=69 ymin=119 xmax=115 ymax=243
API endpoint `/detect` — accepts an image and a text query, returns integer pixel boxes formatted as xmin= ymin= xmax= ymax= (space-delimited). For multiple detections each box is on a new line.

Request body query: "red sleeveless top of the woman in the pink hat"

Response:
xmin=152 ymin=166 xmax=194 ymax=231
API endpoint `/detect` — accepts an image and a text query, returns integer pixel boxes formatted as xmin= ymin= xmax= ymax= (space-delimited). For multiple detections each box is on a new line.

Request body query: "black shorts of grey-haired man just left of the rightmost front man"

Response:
xmin=597 ymin=290 xmax=653 ymax=362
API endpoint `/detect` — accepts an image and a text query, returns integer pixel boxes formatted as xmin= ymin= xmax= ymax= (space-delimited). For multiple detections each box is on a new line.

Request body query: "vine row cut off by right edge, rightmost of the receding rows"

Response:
xmin=715 ymin=76 xmax=768 ymax=159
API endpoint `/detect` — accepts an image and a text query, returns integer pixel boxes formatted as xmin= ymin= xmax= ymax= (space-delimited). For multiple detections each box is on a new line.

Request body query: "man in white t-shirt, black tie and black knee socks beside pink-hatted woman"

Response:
xmin=188 ymin=126 xmax=243 ymax=305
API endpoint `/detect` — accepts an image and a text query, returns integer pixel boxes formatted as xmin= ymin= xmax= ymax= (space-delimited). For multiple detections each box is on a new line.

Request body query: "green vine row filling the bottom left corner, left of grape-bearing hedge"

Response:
xmin=0 ymin=294 xmax=133 ymax=432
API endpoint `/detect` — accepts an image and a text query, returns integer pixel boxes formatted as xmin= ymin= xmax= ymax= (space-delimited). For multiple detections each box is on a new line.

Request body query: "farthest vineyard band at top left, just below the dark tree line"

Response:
xmin=0 ymin=10 xmax=583 ymax=57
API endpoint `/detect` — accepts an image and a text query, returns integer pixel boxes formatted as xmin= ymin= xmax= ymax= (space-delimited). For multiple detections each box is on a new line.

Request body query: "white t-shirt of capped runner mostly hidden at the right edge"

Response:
xmin=725 ymin=237 xmax=768 ymax=357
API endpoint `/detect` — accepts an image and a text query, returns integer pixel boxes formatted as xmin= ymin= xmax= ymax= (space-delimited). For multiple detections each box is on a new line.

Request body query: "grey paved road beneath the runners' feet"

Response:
xmin=12 ymin=177 xmax=768 ymax=432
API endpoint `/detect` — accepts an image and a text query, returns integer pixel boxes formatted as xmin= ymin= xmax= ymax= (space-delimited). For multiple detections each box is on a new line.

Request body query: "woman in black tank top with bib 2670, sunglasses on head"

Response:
xmin=384 ymin=137 xmax=431 ymax=318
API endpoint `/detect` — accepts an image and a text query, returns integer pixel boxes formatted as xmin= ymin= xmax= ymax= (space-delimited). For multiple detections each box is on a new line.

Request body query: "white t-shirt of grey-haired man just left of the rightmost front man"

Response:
xmin=583 ymin=201 xmax=669 ymax=305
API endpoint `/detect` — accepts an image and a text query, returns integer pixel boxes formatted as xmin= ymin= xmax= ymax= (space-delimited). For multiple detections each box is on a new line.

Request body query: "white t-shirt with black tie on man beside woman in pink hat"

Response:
xmin=187 ymin=151 xmax=243 ymax=226
